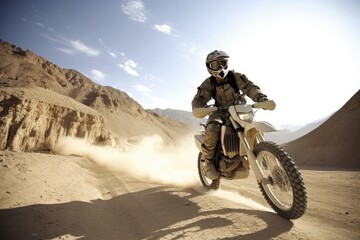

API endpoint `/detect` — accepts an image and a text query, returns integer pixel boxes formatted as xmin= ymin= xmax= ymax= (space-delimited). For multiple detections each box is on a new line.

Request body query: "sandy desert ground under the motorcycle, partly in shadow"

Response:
xmin=0 ymin=138 xmax=360 ymax=240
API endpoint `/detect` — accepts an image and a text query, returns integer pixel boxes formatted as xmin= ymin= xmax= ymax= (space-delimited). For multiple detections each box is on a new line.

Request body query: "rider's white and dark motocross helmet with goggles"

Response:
xmin=206 ymin=50 xmax=229 ymax=78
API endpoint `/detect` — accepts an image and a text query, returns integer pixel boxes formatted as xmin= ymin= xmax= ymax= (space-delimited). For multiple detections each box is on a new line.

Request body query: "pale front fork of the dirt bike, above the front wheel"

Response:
xmin=230 ymin=117 xmax=266 ymax=182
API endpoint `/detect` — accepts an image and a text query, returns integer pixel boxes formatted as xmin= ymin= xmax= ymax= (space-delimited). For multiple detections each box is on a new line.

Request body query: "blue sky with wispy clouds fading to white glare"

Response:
xmin=0 ymin=0 xmax=360 ymax=125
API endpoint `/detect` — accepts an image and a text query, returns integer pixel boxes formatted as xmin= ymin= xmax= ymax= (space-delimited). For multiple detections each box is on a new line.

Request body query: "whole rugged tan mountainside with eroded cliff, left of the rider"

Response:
xmin=0 ymin=40 xmax=189 ymax=151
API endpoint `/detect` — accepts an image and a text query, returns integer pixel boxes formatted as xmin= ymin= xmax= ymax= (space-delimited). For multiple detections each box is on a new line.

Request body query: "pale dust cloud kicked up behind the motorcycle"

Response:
xmin=55 ymin=135 xmax=269 ymax=211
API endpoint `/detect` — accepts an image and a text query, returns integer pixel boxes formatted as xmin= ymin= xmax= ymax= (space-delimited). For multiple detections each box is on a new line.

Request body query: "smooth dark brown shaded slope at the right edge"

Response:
xmin=284 ymin=90 xmax=360 ymax=170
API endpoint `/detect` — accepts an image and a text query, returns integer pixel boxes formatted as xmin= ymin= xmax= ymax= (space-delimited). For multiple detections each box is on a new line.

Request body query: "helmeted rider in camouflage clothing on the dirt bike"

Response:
xmin=192 ymin=50 xmax=268 ymax=180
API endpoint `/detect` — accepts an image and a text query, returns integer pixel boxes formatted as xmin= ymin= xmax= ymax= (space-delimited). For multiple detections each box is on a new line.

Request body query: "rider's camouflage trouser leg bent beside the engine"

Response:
xmin=202 ymin=112 xmax=225 ymax=160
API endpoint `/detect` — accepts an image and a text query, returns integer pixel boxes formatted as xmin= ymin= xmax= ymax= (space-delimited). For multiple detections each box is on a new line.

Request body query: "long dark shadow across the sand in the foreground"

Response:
xmin=0 ymin=187 xmax=293 ymax=240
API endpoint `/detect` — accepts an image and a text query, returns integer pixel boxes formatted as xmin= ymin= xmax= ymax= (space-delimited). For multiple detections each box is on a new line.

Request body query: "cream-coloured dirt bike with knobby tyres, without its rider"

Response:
xmin=193 ymin=94 xmax=307 ymax=219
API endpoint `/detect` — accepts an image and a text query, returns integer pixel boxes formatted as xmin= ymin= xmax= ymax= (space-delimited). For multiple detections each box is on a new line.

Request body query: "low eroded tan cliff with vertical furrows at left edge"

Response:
xmin=0 ymin=88 xmax=110 ymax=151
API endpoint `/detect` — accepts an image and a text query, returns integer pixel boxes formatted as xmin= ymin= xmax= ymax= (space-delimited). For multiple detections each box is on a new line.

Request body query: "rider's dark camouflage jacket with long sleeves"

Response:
xmin=191 ymin=72 xmax=266 ymax=110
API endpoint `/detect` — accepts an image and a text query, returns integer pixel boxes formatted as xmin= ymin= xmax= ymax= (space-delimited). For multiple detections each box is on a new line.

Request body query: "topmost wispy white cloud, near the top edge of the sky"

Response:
xmin=121 ymin=0 xmax=147 ymax=22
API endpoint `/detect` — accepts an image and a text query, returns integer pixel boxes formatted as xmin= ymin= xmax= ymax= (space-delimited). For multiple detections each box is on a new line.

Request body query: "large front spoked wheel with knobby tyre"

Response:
xmin=254 ymin=142 xmax=307 ymax=219
